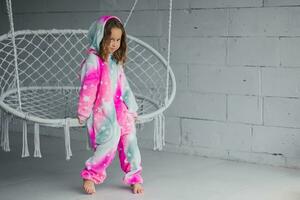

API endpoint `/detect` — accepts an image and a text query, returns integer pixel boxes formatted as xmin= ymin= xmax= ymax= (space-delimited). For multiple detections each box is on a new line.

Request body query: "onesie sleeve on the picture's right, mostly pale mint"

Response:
xmin=121 ymin=69 xmax=139 ymax=114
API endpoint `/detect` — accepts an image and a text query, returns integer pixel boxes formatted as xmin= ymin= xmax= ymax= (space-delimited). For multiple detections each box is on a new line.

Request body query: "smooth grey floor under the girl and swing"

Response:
xmin=0 ymin=135 xmax=300 ymax=200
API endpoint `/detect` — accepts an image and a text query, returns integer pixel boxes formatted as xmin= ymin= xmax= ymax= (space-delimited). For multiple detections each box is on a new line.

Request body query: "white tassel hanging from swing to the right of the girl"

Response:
xmin=153 ymin=113 xmax=165 ymax=151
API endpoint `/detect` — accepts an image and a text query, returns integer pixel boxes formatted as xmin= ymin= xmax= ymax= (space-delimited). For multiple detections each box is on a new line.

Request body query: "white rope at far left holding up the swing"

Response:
xmin=6 ymin=0 xmax=22 ymax=110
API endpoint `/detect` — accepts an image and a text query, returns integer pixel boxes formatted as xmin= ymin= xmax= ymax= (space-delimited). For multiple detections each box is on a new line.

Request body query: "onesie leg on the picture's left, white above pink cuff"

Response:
xmin=81 ymin=127 xmax=120 ymax=184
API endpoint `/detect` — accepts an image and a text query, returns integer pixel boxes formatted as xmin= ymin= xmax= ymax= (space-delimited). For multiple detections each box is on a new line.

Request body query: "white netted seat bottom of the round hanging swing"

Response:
xmin=0 ymin=87 xmax=159 ymax=126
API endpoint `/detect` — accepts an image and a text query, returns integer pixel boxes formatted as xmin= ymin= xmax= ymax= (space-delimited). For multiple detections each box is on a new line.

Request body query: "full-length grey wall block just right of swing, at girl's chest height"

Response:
xmin=188 ymin=65 xmax=259 ymax=95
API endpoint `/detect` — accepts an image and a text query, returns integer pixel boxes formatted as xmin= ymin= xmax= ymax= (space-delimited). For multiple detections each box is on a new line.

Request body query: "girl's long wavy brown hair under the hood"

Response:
xmin=98 ymin=18 xmax=127 ymax=64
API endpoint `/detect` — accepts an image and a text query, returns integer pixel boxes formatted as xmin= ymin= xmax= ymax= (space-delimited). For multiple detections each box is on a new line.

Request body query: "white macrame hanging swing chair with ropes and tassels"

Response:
xmin=0 ymin=0 xmax=176 ymax=160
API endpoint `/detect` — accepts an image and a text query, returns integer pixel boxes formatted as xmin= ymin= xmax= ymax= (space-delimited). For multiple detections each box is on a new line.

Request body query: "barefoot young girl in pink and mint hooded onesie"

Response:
xmin=78 ymin=16 xmax=143 ymax=194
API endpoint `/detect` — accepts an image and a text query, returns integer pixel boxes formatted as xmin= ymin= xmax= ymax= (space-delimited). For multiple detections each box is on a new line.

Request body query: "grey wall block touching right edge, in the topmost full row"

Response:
xmin=229 ymin=7 xmax=300 ymax=37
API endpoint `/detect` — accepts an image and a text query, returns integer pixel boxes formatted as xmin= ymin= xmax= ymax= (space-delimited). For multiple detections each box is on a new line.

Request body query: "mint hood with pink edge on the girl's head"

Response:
xmin=88 ymin=16 xmax=121 ymax=52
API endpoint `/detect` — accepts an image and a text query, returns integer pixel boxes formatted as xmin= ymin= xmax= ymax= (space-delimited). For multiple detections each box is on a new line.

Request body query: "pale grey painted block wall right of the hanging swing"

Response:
xmin=162 ymin=0 xmax=300 ymax=167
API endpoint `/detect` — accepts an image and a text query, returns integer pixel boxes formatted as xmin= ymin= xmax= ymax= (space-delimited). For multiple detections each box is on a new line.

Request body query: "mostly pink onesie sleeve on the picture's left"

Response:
xmin=77 ymin=54 xmax=100 ymax=121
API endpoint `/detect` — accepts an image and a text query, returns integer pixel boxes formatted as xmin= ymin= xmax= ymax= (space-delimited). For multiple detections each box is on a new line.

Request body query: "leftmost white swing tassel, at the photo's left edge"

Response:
xmin=1 ymin=112 xmax=10 ymax=152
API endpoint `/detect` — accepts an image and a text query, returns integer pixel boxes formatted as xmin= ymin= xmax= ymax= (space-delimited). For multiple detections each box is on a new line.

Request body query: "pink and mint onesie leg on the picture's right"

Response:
xmin=118 ymin=114 xmax=143 ymax=184
